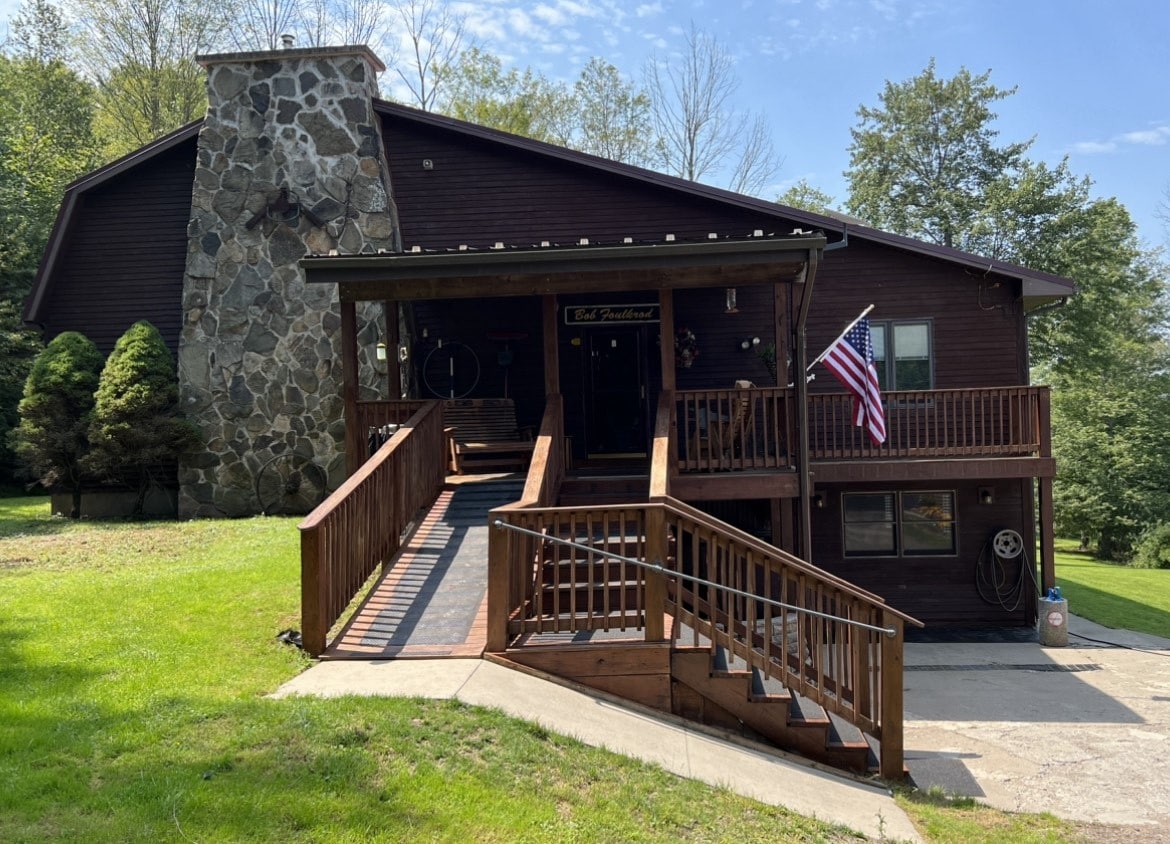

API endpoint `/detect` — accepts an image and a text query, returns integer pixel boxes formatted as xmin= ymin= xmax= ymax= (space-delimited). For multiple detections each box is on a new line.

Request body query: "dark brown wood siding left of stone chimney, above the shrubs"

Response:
xmin=36 ymin=138 xmax=195 ymax=354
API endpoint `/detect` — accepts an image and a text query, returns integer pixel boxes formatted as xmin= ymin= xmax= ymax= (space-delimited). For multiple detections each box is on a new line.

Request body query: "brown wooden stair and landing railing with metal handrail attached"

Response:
xmin=488 ymin=498 xmax=917 ymax=777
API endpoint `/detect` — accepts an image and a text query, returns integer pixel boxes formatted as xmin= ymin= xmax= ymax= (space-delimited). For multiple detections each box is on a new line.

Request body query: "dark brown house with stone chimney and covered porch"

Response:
xmin=26 ymin=41 xmax=1073 ymax=772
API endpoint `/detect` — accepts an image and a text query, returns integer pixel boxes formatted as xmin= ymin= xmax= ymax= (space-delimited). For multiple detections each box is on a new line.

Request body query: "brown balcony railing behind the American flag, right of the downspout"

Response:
xmin=808 ymin=386 xmax=1051 ymax=460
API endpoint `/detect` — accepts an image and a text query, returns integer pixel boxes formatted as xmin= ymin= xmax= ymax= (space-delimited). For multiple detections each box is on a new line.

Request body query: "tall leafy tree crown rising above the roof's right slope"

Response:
xmin=845 ymin=59 xmax=1031 ymax=248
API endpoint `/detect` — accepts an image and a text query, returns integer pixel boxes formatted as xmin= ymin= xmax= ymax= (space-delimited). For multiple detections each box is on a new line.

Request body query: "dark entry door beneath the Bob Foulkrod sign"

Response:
xmin=585 ymin=325 xmax=647 ymax=457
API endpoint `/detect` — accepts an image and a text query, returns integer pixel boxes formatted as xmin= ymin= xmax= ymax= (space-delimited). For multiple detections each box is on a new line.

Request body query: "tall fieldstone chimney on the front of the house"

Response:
xmin=179 ymin=47 xmax=398 ymax=517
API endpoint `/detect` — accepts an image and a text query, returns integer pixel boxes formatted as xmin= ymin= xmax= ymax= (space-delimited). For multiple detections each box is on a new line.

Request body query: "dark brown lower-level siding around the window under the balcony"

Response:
xmin=812 ymin=481 xmax=1035 ymax=626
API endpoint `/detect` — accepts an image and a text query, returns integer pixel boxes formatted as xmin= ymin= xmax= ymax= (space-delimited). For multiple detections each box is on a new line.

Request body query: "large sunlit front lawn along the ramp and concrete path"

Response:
xmin=0 ymin=499 xmax=1074 ymax=844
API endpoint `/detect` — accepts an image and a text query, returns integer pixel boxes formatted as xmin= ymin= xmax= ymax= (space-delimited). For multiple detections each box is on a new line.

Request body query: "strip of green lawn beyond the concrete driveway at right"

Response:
xmin=1057 ymin=540 xmax=1170 ymax=638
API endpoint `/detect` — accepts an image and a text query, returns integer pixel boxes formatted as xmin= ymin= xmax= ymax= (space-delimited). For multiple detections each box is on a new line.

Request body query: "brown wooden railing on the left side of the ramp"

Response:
xmin=300 ymin=402 xmax=446 ymax=657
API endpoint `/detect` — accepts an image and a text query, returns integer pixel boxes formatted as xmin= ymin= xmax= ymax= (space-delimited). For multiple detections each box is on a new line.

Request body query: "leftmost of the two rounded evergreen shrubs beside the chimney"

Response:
xmin=9 ymin=331 xmax=102 ymax=519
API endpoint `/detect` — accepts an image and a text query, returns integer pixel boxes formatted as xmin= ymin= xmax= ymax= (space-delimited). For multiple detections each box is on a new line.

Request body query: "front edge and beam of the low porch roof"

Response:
xmin=301 ymin=234 xmax=825 ymax=302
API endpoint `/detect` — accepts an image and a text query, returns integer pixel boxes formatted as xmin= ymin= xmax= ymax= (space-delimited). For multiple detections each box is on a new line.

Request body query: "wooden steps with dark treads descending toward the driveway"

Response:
xmin=670 ymin=646 xmax=876 ymax=773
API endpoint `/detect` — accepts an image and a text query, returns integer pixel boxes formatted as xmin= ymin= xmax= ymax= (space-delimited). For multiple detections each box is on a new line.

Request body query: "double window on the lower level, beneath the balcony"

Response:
xmin=841 ymin=492 xmax=957 ymax=557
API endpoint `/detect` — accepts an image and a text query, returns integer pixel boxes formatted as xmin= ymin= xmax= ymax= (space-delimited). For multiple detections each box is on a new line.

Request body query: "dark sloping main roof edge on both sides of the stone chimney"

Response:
xmin=25 ymin=100 xmax=1075 ymax=324
